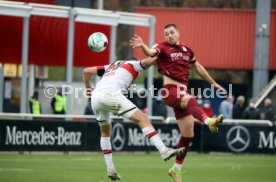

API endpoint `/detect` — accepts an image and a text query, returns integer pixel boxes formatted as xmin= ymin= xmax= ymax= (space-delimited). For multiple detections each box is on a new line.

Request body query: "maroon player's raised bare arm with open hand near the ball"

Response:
xmin=129 ymin=34 xmax=158 ymax=57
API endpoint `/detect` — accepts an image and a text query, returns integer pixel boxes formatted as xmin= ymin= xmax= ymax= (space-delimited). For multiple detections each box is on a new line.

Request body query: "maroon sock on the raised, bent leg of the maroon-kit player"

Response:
xmin=187 ymin=98 xmax=208 ymax=123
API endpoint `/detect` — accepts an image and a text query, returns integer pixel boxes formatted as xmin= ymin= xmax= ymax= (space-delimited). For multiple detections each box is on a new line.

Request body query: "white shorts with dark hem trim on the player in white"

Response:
xmin=91 ymin=89 xmax=138 ymax=126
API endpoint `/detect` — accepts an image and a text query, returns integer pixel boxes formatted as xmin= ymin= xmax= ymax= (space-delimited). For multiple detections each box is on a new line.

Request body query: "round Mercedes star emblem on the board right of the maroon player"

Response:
xmin=226 ymin=125 xmax=250 ymax=152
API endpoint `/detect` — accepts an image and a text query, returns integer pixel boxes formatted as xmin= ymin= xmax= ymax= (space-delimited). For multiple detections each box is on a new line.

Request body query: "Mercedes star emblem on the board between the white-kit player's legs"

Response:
xmin=112 ymin=123 xmax=126 ymax=151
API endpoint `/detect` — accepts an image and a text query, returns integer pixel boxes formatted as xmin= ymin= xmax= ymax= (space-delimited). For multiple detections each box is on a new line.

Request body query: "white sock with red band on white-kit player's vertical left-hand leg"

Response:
xmin=101 ymin=137 xmax=115 ymax=171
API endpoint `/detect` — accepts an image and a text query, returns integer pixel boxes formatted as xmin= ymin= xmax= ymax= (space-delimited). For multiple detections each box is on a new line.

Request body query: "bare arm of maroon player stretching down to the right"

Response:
xmin=193 ymin=61 xmax=225 ymax=93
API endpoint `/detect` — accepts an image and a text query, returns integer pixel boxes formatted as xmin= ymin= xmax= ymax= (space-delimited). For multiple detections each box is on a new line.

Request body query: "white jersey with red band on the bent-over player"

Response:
xmin=95 ymin=60 xmax=144 ymax=90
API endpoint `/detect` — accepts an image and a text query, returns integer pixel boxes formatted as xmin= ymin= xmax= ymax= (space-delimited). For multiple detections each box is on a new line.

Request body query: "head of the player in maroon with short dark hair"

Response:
xmin=164 ymin=24 xmax=180 ymax=44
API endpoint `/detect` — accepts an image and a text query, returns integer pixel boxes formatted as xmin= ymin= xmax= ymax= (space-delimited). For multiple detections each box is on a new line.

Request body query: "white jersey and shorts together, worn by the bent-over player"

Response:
xmin=91 ymin=61 xmax=143 ymax=123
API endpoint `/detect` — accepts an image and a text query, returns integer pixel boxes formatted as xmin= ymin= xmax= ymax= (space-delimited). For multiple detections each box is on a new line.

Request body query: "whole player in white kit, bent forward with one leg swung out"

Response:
xmin=83 ymin=58 xmax=184 ymax=180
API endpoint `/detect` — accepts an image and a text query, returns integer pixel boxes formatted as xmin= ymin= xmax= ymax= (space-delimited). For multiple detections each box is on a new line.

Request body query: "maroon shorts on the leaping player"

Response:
xmin=161 ymin=84 xmax=189 ymax=119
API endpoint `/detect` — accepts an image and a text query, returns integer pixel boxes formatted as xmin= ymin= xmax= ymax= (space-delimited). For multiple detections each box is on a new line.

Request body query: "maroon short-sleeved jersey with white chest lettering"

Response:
xmin=155 ymin=42 xmax=195 ymax=86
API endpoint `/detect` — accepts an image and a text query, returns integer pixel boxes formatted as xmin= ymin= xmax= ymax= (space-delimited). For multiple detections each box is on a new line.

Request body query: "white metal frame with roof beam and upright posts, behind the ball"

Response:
xmin=0 ymin=1 xmax=155 ymax=115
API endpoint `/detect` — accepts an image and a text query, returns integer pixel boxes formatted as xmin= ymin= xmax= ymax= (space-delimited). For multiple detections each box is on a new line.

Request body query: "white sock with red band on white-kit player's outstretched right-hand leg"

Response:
xmin=142 ymin=127 xmax=167 ymax=153
